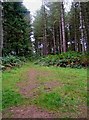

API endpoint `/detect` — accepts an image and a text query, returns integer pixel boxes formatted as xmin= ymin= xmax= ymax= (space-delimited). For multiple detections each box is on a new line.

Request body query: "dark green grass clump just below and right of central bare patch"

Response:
xmin=34 ymin=93 xmax=62 ymax=110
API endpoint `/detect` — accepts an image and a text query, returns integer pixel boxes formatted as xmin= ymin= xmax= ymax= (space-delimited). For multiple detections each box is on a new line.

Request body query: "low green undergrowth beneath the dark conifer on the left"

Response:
xmin=0 ymin=55 xmax=33 ymax=70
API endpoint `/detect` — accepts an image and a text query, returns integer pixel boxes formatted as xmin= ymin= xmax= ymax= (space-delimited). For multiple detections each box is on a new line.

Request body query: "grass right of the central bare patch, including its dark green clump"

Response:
xmin=34 ymin=67 xmax=87 ymax=112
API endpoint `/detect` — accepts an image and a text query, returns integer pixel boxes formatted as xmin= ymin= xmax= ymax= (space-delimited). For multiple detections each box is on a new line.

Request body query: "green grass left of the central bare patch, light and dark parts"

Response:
xmin=2 ymin=63 xmax=31 ymax=109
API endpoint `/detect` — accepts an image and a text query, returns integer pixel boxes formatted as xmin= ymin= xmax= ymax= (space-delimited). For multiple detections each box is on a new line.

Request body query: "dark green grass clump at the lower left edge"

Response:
xmin=2 ymin=89 xmax=22 ymax=109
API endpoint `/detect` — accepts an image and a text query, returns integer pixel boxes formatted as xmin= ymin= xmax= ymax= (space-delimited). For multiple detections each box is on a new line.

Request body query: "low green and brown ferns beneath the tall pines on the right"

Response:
xmin=35 ymin=51 xmax=89 ymax=68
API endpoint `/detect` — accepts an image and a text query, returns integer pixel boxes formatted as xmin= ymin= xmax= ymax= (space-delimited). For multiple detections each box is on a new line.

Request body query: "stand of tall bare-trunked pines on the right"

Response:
xmin=33 ymin=2 xmax=89 ymax=55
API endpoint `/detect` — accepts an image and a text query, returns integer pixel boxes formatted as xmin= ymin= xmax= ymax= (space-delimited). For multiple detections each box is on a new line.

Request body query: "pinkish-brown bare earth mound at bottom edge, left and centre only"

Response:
xmin=3 ymin=105 xmax=54 ymax=118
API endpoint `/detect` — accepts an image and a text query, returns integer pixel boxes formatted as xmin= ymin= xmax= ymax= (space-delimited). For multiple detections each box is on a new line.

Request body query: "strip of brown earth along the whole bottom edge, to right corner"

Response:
xmin=2 ymin=105 xmax=87 ymax=119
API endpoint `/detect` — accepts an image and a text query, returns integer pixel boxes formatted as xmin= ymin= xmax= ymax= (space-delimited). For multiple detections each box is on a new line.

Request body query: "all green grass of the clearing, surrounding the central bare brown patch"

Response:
xmin=2 ymin=62 xmax=87 ymax=116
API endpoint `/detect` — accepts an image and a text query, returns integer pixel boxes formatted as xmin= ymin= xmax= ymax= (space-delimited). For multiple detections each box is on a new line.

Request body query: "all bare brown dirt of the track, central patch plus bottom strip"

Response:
xmin=3 ymin=69 xmax=87 ymax=118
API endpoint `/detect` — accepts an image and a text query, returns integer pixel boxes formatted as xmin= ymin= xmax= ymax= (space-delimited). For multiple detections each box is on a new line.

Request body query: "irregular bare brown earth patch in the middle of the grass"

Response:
xmin=17 ymin=69 xmax=62 ymax=98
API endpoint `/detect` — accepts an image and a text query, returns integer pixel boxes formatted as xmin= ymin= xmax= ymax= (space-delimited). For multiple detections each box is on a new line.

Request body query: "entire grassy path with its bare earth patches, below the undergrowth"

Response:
xmin=2 ymin=62 xmax=87 ymax=118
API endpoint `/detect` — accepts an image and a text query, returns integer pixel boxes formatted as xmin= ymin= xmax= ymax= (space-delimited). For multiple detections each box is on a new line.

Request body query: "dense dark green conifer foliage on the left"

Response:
xmin=3 ymin=2 xmax=31 ymax=56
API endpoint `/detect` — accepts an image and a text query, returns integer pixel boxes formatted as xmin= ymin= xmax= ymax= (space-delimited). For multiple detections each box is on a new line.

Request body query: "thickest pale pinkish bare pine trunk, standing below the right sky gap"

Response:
xmin=61 ymin=2 xmax=66 ymax=52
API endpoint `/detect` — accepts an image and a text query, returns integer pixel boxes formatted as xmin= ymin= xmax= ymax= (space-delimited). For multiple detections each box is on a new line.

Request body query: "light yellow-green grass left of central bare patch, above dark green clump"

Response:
xmin=2 ymin=63 xmax=31 ymax=90
